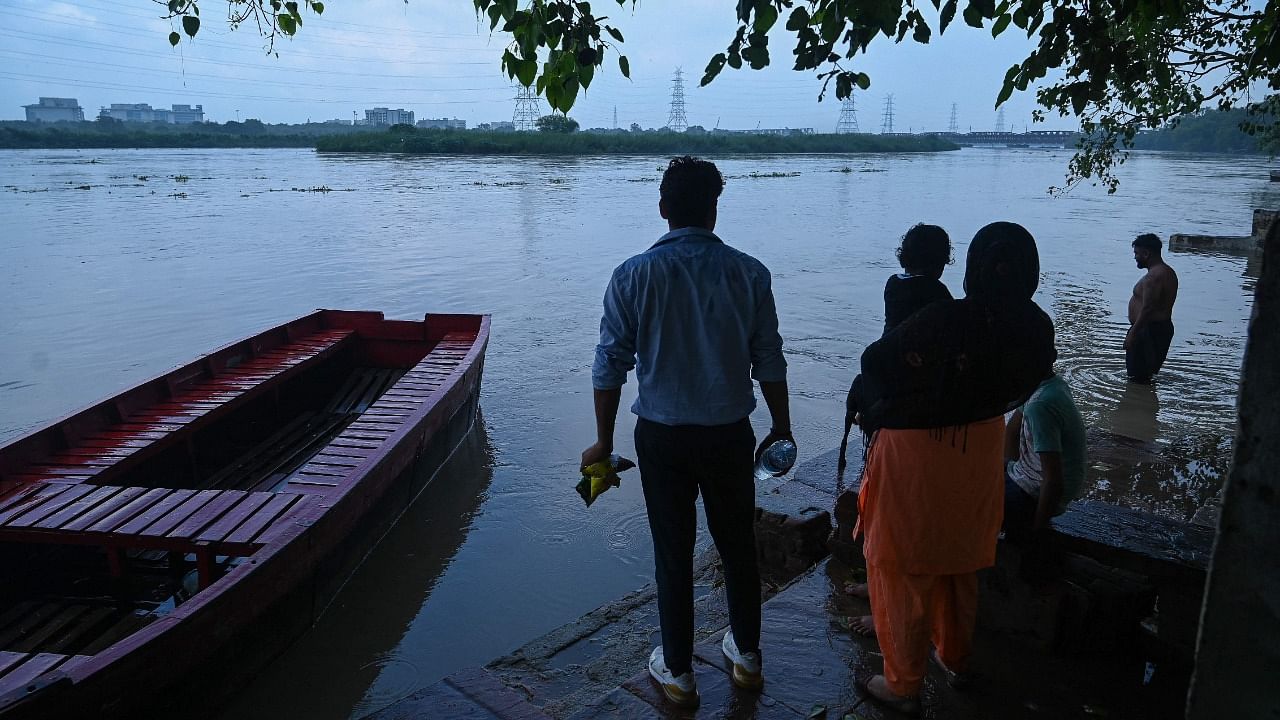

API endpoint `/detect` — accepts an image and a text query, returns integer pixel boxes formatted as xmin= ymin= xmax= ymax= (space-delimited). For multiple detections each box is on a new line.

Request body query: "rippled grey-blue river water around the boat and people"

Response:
xmin=0 ymin=149 xmax=1280 ymax=719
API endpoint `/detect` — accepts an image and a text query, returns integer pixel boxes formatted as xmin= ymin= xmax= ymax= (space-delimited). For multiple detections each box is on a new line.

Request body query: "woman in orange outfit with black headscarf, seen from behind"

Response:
xmin=854 ymin=223 xmax=1056 ymax=712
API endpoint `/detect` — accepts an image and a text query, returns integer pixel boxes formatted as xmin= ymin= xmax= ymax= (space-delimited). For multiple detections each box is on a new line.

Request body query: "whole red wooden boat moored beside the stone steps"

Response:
xmin=0 ymin=310 xmax=489 ymax=720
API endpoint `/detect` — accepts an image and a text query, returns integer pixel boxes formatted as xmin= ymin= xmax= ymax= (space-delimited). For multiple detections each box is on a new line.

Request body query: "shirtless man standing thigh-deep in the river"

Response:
xmin=1124 ymin=233 xmax=1178 ymax=384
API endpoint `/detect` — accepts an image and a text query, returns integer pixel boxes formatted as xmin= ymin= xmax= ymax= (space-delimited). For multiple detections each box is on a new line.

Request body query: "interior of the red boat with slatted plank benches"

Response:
xmin=0 ymin=311 xmax=475 ymax=687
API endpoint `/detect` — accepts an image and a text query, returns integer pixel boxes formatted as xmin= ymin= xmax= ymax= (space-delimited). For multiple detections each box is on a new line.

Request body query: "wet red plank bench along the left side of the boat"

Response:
xmin=9 ymin=329 xmax=355 ymax=483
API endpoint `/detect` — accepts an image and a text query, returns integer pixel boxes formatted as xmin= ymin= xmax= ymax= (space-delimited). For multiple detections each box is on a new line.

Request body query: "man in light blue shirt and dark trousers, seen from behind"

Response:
xmin=582 ymin=156 xmax=795 ymax=707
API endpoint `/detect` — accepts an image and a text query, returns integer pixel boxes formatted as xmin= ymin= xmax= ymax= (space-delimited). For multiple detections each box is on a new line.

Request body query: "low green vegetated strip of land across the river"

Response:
xmin=316 ymin=126 xmax=960 ymax=155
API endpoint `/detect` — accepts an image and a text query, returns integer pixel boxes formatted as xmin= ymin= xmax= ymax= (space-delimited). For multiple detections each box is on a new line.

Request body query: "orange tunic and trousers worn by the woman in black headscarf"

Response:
xmin=854 ymin=416 xmax=1005 ymax=696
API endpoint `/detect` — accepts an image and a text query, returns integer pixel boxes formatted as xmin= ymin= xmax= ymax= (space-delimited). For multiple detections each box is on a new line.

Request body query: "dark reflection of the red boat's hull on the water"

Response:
xmin=221 ymin=416 xmax=494 ymax=720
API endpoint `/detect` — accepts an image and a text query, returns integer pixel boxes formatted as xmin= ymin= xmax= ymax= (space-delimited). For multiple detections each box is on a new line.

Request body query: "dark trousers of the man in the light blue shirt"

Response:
xmin=635 ymin=418 xmax=760 ymax=675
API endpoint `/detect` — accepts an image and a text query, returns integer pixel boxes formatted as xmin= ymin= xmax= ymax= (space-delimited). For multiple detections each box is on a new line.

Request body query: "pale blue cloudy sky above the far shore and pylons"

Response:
xmin=0 ymin=0 xmax=1075 ymax=132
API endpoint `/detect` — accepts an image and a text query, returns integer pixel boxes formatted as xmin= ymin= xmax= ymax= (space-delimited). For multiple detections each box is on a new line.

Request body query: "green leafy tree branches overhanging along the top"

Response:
xmin=164 ymin=0 xmax=1280 ymax=191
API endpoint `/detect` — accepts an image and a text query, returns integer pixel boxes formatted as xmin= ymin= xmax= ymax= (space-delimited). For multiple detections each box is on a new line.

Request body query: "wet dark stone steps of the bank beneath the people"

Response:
xmin=367 ymin=443 xmax=1212 ymax=720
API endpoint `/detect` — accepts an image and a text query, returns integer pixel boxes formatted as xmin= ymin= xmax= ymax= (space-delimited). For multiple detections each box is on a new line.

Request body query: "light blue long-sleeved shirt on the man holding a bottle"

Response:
xmin=591 ymin=228 xmax=787 ymax=425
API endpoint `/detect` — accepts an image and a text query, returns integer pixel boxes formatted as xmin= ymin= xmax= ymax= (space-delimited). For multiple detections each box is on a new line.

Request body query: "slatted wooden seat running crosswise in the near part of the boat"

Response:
xmin=0 ymin=482 xmax=315 ymax=588
